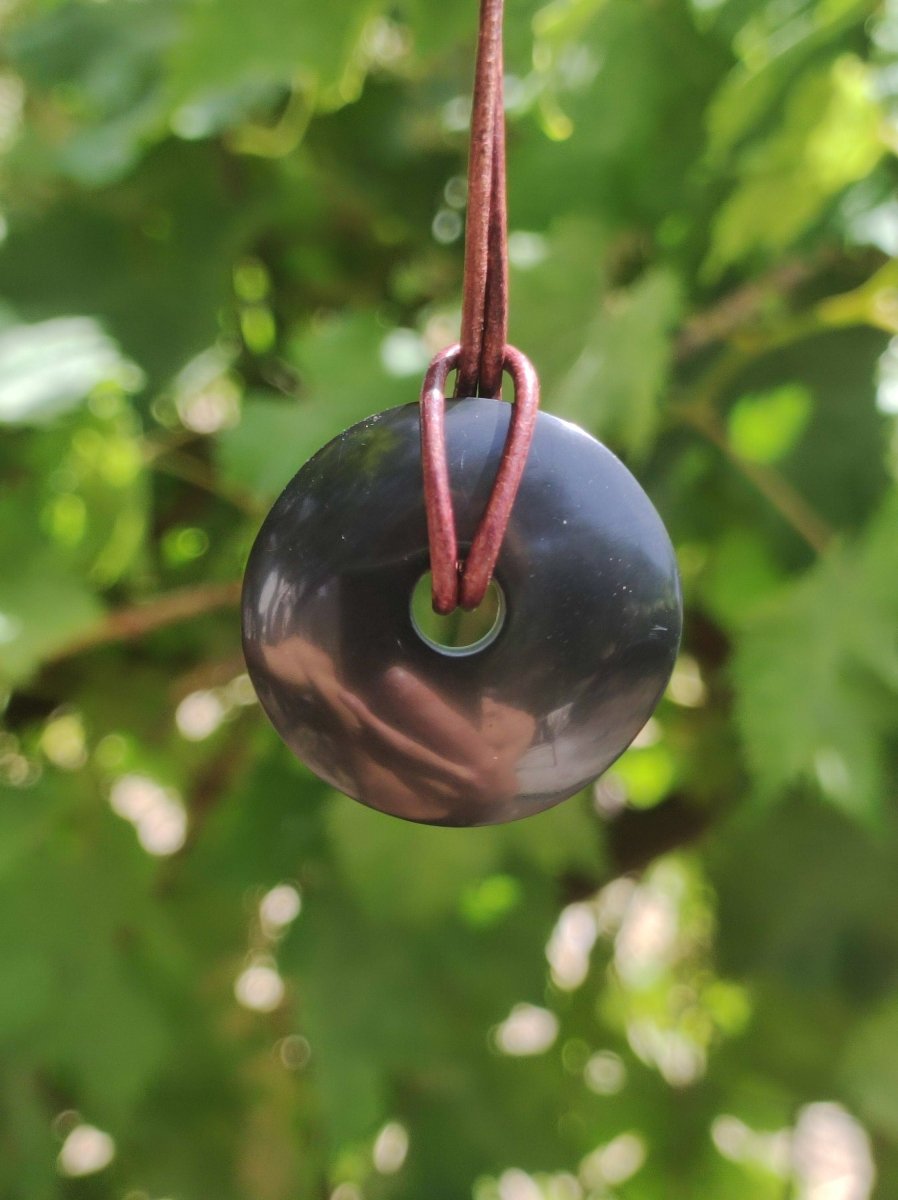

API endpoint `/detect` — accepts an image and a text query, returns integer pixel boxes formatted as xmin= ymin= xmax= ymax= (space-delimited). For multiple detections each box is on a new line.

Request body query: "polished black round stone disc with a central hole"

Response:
xmin=243 ymin=400 xmax=682 ymax=826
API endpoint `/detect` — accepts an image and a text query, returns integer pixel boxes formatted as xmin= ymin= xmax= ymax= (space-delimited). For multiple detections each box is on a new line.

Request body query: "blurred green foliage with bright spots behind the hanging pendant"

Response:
xmin=0 ymin=0 xmax=898 ymax=1200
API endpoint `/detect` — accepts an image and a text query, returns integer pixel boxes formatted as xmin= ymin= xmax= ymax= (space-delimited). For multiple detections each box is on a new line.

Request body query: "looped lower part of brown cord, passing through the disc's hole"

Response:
xmin=421 ymin=344 xmax=539 ymax=613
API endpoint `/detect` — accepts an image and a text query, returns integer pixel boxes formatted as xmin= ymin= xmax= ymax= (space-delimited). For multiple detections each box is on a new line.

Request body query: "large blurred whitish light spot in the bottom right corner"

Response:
xmin=792 ymin=1104 xmax=876 ymax=1200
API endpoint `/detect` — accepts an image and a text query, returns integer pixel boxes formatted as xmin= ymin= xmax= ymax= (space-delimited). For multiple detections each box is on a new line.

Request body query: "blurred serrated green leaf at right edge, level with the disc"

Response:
xmin=732 ymin=487 xmax=898 ymax=818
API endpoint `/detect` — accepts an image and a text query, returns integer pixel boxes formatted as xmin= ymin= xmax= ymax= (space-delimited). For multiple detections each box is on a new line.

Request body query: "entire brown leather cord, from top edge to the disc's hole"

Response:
xmin=420 ymin=0 xmax=539 ymax=613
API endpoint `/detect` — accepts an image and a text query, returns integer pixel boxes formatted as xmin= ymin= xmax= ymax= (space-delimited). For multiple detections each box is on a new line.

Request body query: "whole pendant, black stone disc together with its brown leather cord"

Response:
xmin=243 ymin=0 xmax=682 ymax=826
